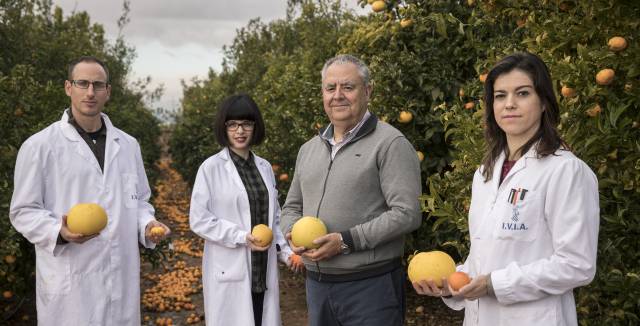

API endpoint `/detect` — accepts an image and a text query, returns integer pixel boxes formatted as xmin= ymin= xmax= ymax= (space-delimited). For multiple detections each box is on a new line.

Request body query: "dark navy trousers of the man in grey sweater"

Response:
xmin=306 ymin=268 xmax=406 ymax=326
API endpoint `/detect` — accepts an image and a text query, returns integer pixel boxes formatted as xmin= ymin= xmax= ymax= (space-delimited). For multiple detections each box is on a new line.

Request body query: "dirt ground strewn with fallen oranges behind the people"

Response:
xmin=0 ymin=160 xmax=462 ymax=326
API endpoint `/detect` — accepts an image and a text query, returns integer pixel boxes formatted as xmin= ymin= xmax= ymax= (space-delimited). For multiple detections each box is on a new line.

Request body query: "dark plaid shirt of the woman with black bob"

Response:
xmin=229 ymin=149 xmax=269 ymax=293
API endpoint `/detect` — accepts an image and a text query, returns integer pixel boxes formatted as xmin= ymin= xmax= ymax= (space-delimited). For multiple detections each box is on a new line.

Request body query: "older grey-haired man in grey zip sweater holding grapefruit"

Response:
xmin=281 ymin=55 xmax=421 ymax=326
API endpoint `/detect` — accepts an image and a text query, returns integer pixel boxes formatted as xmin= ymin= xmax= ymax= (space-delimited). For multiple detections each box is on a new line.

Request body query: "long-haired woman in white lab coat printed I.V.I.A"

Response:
xmin=414 ymin=53 xmax=600 ymax=326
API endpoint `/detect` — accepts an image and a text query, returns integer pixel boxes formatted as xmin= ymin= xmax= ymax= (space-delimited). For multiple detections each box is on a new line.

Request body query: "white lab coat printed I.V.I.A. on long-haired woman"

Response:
xmin=445 ymin=146 xmax=600 ymax=326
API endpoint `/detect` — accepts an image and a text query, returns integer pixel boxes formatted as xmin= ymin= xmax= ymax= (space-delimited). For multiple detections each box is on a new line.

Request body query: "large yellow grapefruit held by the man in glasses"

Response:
xmin=67 ymin=203 xmax=107 ymax=235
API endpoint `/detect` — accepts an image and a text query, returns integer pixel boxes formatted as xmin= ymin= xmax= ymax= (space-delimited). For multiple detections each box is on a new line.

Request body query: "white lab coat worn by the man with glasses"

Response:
xmin=9 ymin=111 xmax=154 ymax=326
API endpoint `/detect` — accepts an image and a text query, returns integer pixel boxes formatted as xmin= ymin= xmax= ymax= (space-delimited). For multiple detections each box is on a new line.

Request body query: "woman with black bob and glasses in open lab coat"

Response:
xmin=189 ymin=94 xmax=302 ymax=326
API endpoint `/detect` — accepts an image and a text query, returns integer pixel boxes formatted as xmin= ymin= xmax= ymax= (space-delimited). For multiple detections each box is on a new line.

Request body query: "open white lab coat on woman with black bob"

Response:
xmin=189 ymin=148 xmax=291 ymax=326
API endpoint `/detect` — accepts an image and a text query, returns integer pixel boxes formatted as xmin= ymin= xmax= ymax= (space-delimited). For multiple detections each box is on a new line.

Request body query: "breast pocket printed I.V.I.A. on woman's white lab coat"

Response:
xmin=493 ymin=191 xmax=544 ymax=241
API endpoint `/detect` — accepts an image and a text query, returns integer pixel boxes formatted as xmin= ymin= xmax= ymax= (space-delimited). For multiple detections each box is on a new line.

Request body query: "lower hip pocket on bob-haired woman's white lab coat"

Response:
xmin=213 ymin=246 xmax=248 ymax=282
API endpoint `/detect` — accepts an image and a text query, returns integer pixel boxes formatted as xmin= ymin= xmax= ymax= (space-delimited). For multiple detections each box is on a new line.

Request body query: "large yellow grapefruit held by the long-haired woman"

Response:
xmin=407 ymin=251 xmax=456 ymax=286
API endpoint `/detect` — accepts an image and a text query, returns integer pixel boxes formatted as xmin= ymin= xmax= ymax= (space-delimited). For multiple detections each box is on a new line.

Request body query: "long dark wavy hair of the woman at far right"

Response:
xmin=482 ymin=52 xmax=569 ymax=182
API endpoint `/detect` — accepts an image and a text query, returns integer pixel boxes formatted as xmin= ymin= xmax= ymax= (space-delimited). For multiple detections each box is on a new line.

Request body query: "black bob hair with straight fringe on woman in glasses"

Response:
xmin=214 ymin=94 xmax=265 ymax=146
